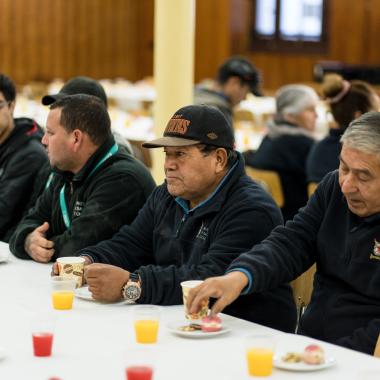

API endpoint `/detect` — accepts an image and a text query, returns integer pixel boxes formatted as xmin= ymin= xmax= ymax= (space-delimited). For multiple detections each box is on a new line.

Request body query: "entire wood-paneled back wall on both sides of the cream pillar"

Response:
xmin=0 ymin=0 xmax=380 ymax=89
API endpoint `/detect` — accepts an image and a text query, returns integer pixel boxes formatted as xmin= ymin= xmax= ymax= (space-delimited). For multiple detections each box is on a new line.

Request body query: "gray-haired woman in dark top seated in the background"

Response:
xmin=245 ymin=84 xmax=318 ymax=221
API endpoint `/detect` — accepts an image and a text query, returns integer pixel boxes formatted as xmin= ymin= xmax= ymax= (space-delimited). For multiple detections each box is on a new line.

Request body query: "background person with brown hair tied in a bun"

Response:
xmin=306 ymin=74 xmax=380 ymax=183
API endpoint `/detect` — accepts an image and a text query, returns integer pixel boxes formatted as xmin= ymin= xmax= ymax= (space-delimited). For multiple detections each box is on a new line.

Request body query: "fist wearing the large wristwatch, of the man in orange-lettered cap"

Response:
xmin=84 ymin=263 xmax=129 ymax=302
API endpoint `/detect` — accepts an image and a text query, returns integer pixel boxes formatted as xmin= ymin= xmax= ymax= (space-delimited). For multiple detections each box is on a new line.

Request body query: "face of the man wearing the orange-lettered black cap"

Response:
xmin=164 ymin=146 xmax=223 ymax=208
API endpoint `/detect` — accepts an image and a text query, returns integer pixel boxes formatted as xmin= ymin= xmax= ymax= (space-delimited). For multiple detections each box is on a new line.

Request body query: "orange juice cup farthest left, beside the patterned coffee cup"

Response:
xmin=51 ymin=276 xmax=76 ymax=310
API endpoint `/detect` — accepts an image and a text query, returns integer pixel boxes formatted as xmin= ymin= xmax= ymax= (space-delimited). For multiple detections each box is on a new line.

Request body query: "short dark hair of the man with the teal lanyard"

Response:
xmin=50 ymin=94 xmax=111 ymax=145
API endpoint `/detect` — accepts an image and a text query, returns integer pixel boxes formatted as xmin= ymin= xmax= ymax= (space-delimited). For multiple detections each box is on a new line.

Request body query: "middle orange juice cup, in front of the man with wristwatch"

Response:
xmin=133 ymin=305 xmax=160 ymax=344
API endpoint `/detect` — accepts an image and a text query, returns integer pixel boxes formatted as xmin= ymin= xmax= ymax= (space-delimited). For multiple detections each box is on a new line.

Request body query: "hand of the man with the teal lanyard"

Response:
xmin=24 ymin=222 xmax=54 ymax=263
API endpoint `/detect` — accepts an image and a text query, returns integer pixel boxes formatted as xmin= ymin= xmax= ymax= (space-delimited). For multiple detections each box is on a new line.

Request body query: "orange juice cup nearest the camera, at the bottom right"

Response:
xmin=245 ymin=335 xmax=275 ymax=377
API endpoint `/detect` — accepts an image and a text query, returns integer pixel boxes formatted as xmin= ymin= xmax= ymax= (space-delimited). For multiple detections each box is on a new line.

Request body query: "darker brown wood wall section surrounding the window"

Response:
xmin=230 ymin=0 xmax=380 ymax=90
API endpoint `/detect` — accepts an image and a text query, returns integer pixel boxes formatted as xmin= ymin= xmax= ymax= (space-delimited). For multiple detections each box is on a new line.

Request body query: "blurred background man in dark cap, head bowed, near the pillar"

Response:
xmin=194 ymin=56 xmax=261 ymax=122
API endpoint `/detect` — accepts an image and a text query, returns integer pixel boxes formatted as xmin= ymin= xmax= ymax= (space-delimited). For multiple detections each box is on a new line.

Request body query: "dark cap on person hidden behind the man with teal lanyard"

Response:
xmin=42 ymin=76 xmax=107 ymax=107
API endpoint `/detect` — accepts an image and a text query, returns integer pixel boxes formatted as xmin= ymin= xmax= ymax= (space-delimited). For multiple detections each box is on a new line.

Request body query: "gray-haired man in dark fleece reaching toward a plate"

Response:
xmin=189 ymin=112 xmax=380 ymax=355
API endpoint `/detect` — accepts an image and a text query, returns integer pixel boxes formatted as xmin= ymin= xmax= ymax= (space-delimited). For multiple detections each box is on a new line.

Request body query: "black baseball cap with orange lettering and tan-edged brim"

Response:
xmin=142 ymin=104 xmax=235 ymax=149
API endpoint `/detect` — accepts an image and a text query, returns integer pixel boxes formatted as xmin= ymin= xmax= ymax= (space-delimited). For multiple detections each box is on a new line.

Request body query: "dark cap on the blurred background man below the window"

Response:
xmin=218 ymin=56 xmax=262 ymax=96
